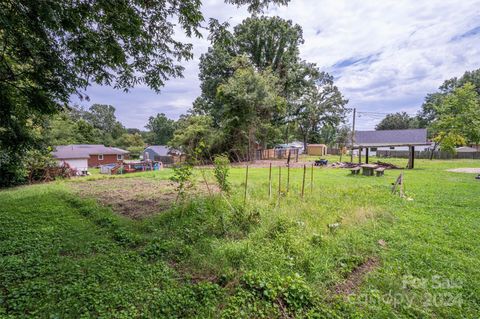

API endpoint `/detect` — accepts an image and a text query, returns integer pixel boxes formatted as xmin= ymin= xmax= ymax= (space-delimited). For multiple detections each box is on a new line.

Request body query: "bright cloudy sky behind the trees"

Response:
xmin=72 ymin=0 xmax=480 ymax=130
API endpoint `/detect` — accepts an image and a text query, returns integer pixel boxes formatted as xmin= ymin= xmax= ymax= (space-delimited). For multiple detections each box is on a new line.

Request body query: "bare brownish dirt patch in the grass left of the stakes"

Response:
xmin=71 ymin=178 xmax=216 ymax=219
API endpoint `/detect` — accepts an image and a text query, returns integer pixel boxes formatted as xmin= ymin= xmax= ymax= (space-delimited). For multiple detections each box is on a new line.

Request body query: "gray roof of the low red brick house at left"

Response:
xmin=52 ymin=144 xmax=129 ymax=159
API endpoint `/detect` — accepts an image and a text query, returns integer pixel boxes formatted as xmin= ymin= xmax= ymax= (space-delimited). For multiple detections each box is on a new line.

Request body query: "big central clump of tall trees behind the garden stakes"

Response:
xmin=193 ymin=16 xmax=347 ymax=158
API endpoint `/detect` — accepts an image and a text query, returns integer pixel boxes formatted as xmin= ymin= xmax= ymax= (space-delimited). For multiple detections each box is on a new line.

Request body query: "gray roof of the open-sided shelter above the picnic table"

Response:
xmin=353 ymin=129 xmax=429 ymax=147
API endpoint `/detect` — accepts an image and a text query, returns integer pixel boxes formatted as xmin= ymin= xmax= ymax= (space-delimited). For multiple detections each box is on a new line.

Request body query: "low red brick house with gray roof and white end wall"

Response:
xmin=52 ymin=144 xmax=129 ymax=171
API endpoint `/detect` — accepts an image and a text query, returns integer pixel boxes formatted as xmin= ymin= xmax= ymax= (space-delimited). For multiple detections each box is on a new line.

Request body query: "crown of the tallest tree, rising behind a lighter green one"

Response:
xmin=194 ymin=16 xmax=303 ymax=125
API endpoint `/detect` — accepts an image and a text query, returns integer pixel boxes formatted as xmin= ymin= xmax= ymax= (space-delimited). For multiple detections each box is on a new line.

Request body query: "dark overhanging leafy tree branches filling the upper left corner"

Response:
xmin=0 ymin=0 xmax=288 ymax=188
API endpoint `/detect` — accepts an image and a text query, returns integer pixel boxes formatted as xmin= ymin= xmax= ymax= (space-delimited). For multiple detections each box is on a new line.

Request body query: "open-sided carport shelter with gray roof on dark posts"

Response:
xmin=352 ymin=129 xmax=430 ymax=169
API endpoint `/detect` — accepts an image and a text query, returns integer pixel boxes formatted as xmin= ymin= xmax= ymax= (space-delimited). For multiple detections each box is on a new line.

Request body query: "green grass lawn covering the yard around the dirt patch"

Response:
xmin=0 ymin=157 xmax=480 ymax=318
